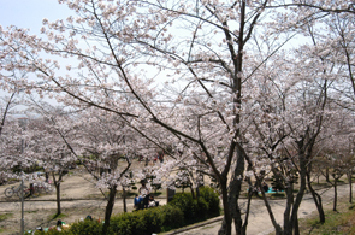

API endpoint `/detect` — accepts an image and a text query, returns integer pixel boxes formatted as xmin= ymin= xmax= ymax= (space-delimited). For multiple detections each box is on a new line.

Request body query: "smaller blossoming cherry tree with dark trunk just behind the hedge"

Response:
xmin=72 ymin=109 xmax=136 ymax=229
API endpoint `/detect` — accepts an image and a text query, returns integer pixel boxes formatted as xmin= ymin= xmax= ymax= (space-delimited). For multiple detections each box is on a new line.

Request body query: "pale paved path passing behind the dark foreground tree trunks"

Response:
xmin=180 ymin=184 xmax=354 ymax=235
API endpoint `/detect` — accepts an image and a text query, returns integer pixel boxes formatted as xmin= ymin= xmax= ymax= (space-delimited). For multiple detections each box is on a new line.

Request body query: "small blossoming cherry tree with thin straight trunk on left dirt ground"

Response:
xmin=24 ymin=102 xmax=77 ymax=216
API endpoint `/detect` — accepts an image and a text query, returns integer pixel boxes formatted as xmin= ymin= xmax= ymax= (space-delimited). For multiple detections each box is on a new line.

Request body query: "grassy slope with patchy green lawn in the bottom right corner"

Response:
xmin=299 ymin=197 xmax=355 ymax=235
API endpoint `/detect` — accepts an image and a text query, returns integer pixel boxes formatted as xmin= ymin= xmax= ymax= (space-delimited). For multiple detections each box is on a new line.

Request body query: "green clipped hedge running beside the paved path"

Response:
xmin=35 ymin=187 xmax=219 ymax=235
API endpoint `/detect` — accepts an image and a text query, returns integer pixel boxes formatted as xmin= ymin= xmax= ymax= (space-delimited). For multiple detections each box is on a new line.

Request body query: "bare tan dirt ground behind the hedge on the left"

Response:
xmin=0 ymin=169 xmax=145 ymax=234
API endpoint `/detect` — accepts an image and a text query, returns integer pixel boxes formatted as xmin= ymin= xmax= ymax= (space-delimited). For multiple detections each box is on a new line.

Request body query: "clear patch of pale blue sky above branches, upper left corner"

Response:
xmin=0 ymin=0 xmax=71 ymax=34
